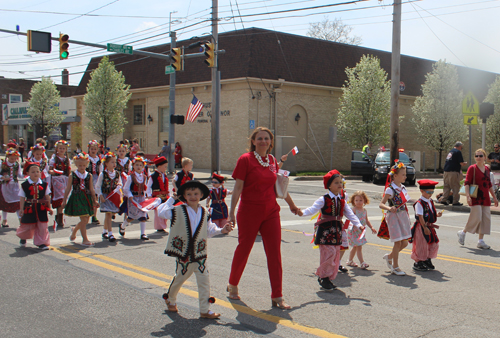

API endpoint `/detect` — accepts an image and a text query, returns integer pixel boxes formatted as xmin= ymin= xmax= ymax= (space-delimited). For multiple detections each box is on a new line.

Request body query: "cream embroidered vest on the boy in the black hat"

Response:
xmin=165 ymin=204 xmax=208 ymax=262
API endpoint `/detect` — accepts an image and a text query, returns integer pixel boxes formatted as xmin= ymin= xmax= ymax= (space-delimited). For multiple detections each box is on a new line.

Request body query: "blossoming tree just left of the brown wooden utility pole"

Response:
xmin=337 ymin=55 xmax=391 ymax=149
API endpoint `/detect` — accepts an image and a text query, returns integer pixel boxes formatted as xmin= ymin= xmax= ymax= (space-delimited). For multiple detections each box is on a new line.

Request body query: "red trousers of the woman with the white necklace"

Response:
xmin=229 ymin=202 xmax=283 ymax=298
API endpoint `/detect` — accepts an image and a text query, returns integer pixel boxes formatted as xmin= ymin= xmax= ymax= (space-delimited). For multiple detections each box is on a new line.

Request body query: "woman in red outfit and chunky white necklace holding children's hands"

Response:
xmin=227 ymin=127 xmax=299 ymax=309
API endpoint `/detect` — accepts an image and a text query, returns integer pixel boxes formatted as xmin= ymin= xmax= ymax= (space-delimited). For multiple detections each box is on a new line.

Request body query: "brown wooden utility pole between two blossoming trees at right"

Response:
xmin=390 ymin=0 xmax=401 ymax=166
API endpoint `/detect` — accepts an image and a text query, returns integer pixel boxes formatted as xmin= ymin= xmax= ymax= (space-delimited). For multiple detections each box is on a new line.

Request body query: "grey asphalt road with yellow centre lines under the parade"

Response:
xmin=0 ymin=181 xmax=500 ymax=338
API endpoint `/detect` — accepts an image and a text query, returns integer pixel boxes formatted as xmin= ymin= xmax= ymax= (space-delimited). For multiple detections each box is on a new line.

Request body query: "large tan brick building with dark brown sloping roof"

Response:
xmin=74 ymin=28 xmax=496 ymax=171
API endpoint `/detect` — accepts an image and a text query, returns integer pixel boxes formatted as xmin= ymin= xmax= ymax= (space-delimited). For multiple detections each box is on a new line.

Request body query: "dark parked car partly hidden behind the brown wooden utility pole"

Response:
xmin=351 ymin=150 xmax=416 ymax=185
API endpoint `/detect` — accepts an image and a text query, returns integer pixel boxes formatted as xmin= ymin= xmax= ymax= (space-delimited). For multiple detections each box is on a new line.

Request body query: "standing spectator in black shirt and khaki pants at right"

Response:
xmin=439 ymin=142 xmax=467 ymax=205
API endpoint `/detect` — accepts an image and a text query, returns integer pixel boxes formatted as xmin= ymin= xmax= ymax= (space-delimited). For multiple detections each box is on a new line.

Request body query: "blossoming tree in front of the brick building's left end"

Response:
xmin=83 ymin=56 xmax=132 ymax=146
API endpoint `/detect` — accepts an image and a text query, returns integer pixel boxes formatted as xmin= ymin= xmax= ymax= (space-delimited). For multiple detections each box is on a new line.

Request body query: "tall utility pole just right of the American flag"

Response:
xmin=211 ymin=0 xmax=220 ymax=173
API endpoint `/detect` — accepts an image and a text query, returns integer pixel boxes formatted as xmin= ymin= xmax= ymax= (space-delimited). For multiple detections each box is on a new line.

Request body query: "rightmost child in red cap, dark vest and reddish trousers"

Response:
xmin=410 ymin=180 xmax=443 ymax=271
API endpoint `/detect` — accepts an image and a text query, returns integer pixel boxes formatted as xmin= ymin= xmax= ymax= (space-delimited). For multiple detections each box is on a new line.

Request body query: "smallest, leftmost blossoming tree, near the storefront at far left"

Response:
xmin=28 ymin=77 xmax=64 ymax=137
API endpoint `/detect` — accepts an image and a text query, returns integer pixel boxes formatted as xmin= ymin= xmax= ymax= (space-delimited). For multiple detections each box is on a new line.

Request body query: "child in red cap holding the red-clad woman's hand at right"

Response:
xmin=298 ymin=170 xmax=365 ymax=290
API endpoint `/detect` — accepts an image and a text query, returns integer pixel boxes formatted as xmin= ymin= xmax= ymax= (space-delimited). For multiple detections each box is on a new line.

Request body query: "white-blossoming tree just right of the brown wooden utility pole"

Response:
xmin=412 ymin=60 xmax=467 ymax=170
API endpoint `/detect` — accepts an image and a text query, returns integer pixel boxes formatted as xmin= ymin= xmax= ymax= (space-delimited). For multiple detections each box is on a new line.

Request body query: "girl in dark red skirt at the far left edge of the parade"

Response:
xmin=0 ymin=148 xmax=23 ymax=228
